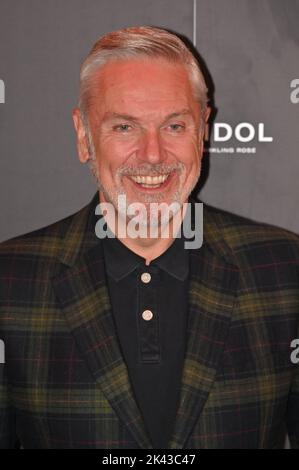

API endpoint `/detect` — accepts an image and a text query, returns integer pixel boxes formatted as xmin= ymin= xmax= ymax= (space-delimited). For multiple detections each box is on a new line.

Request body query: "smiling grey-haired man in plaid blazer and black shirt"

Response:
xmin=0 ymin=27 xmax=299 ymax=449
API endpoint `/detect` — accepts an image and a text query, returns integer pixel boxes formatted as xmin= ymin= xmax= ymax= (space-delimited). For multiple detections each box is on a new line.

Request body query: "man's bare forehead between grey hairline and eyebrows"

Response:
xmin=90 ymin=58 xmax=195 ymax=115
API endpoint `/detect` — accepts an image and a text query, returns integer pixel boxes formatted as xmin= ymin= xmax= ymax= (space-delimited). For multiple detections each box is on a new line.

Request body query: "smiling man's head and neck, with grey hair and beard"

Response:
xmin=73 ymin=28 xmax=209 ymax=263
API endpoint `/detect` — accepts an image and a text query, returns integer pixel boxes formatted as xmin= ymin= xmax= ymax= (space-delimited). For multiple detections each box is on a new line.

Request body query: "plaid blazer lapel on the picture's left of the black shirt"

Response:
xmin=53 ymin=195 xmax=152 ymax=449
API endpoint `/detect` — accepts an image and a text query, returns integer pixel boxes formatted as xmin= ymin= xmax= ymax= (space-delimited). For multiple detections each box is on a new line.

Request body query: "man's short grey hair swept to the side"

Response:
xmin=78 ymin=26 xmax=208 ymax=127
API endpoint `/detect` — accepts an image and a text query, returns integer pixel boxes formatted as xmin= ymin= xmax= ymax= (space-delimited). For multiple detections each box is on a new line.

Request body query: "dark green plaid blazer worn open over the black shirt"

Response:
xmin=0 ymin=194 xmax=299 ymax=449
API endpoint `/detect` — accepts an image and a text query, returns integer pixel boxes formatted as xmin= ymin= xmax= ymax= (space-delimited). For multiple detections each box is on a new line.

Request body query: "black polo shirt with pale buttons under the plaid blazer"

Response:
xmin=103 ymin=221 xmax=189 ymax=448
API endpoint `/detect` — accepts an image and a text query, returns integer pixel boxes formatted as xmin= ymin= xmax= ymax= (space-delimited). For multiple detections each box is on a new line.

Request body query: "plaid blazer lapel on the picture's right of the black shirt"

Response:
xmin=169 ymin=205 xmax=239 ymax=449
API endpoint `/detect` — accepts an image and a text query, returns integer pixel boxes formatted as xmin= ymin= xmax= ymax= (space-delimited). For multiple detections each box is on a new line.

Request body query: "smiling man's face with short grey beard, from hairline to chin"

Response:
xmin=77 ymin=59 xmax=207 ymax=223
